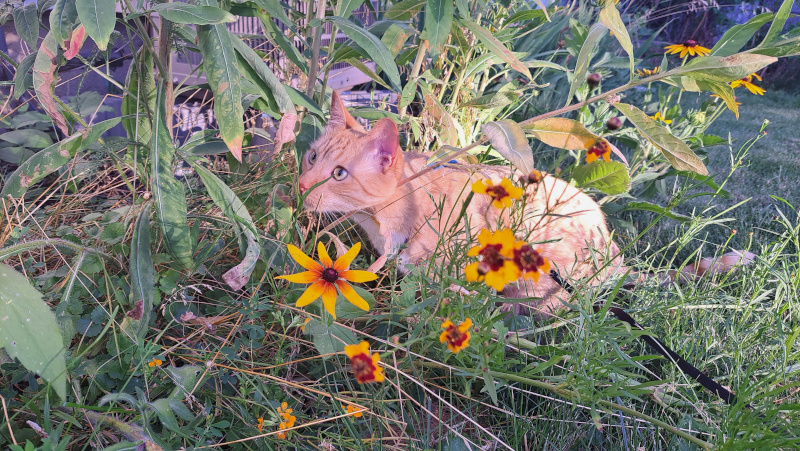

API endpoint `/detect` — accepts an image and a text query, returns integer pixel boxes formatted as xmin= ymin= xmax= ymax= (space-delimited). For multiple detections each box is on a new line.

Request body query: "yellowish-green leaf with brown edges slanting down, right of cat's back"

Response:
xmin=614 ymin=102 xmax=708 ymax=175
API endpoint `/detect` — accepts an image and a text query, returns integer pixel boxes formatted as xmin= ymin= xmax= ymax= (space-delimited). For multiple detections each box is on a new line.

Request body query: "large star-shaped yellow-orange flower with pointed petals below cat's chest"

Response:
xmin=276 ymin=243 xmax=378 ymax=319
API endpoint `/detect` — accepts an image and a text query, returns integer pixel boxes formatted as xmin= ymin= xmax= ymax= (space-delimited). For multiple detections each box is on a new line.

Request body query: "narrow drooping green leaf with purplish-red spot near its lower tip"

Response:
xmin=128 ymin=202 xmax=156 ymax=343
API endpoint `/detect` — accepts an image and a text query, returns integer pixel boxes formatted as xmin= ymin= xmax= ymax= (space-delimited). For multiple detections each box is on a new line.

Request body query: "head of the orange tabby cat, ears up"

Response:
xmin=298 ymin=91 xmax=403 ymax=213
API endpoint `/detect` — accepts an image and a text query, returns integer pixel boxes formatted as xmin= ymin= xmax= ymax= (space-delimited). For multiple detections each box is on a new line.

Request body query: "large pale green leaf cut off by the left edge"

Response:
xmin=0 ymin=263 xmax=67 ymax=401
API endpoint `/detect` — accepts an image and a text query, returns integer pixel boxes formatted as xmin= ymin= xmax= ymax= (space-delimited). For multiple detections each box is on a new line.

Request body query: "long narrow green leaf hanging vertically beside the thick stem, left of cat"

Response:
xmin=150 ymin=84 xmax=194 ymax=269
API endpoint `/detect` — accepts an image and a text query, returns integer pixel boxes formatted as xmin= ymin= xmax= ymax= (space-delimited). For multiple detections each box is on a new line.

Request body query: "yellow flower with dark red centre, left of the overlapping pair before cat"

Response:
xmin=464 ymin=229 xmax=520 ymax=291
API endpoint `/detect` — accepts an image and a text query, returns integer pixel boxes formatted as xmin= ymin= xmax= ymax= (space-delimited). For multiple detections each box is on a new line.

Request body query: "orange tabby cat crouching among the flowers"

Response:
xmin=299 ymin=92 xmax=752 ymax=313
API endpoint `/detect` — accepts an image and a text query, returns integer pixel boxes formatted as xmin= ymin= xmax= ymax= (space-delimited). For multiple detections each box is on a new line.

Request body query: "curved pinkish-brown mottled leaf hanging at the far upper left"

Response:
xmin=33 ymin=31 xmax=69 ymax=135
